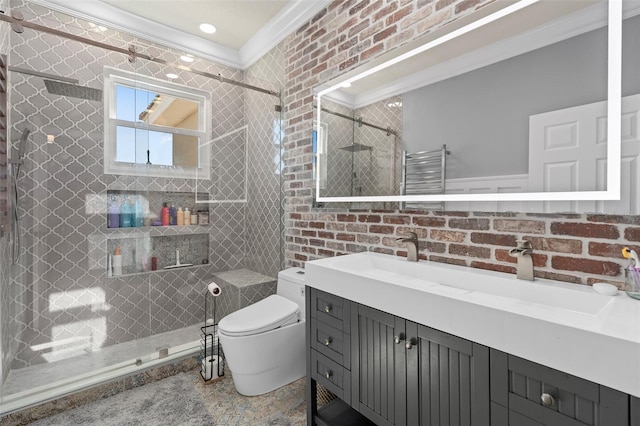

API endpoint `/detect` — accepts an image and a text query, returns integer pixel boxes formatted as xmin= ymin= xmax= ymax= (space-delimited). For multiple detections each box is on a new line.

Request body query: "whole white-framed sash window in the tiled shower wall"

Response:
xmin=104 ymin=68 xmax=210 ymax=179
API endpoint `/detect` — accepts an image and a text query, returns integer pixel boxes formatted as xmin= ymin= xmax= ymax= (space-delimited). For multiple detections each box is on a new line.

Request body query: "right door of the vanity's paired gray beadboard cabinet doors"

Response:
xmin=406 ymin=322 xmax=489 ymax=426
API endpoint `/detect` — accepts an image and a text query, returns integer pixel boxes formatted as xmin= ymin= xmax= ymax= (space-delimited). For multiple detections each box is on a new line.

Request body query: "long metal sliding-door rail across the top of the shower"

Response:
xmin=0 ymin=13 xmax=280 ymax=98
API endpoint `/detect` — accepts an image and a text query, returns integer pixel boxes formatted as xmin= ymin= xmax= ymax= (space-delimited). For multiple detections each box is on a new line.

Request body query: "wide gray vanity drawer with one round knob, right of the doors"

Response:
xmin=492 ymin=354 xmax=629 ymax=426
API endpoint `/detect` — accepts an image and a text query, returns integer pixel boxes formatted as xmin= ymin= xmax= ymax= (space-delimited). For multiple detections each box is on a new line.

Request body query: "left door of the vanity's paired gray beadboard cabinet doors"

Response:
xmin=351 ymin=303 xmax=407 ymax=425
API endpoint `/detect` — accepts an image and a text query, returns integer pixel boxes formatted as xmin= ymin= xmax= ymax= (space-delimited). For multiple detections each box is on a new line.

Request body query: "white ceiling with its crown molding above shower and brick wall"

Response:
xmin=33 ymin=0 xmax=330 ymax=69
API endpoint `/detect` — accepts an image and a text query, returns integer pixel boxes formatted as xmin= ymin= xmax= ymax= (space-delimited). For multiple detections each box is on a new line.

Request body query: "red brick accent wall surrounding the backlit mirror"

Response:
xmin=284 ymin=0 xmax=640 ymax=286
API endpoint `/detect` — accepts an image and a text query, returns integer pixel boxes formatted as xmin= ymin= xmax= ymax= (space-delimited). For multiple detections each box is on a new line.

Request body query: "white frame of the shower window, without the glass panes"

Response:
xmin=104 ymin=67 xmax=211 ymax=180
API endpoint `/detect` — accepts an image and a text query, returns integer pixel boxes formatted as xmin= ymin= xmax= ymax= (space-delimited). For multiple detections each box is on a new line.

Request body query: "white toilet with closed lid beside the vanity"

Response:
xmin=218 ymin=268 xmax=306 ymax=396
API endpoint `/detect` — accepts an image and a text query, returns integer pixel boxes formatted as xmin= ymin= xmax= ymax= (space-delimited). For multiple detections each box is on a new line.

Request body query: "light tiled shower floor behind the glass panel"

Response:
xmin=2 ymin=324 xmax=201 ymax=397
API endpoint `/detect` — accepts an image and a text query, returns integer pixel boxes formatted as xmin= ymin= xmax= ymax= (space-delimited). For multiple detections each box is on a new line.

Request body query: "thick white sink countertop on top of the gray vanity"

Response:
xmin=305 ymin=252 xmax=640 ymax=397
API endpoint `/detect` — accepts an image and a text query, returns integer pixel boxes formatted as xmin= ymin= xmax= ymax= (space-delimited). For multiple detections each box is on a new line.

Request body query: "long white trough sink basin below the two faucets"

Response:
xmin=312 ymin=252 xmax=613 ymax=315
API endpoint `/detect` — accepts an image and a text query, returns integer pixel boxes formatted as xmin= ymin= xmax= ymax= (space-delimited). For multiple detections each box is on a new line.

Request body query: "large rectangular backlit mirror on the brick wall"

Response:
xmin=314 ymin=0 xmax=640 ymax=214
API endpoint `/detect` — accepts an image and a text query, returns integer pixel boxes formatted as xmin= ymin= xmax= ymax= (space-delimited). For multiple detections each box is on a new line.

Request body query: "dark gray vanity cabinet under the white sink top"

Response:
xmin=306 ymin=287 xmax=640 ymax=426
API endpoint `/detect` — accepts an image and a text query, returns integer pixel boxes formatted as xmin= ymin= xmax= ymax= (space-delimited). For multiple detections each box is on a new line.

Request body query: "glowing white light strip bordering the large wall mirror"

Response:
xmin=315 ymin=0 xmax=622 ymax=202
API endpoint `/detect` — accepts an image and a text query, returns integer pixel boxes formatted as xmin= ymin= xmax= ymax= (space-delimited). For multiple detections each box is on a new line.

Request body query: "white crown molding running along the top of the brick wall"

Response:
xmin=239 ymin=0 xmax=331 ymax=68
